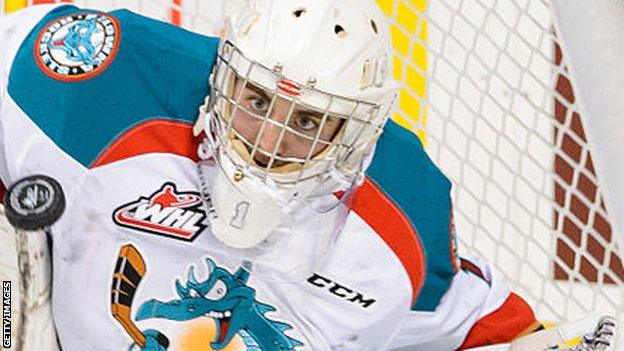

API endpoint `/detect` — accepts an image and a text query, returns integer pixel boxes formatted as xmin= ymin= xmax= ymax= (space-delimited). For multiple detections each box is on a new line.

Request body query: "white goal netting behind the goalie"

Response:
xmin=5 ymin=0 xmax=624 ymax=344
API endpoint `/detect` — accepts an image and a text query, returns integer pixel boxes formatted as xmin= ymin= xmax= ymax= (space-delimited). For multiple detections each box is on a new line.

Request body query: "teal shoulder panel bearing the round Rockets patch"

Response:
xmin=8 ymin=6 xmax=219 ymax=167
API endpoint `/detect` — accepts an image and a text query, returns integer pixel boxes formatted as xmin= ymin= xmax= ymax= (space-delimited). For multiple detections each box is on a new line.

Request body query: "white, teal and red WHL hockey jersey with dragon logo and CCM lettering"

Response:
xmin=0 ymin=5 xmax=536 ymax=351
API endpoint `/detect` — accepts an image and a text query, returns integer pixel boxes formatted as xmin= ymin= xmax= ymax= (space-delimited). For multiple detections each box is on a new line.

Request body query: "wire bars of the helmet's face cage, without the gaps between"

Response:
xmin=208 ymin=40 xmax=392 ymax=187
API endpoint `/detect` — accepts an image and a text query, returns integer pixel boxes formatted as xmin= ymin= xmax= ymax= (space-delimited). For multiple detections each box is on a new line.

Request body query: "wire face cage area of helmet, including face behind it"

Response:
xmin=209 ymin=40 xmax=389 ymax=186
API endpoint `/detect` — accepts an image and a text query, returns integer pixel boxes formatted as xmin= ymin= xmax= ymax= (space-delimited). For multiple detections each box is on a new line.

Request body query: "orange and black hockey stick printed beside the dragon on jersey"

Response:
xmin=111 ymin=245 xmax=146 ymax=347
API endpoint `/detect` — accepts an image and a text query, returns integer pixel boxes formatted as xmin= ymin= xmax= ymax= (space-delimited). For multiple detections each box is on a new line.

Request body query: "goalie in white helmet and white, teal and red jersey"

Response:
xmin=0 ymin=0 xmax=612 ymax=351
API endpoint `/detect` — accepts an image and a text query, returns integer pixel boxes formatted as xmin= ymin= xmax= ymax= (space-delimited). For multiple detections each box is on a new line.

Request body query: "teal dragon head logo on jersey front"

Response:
xmin=131 ymin=259 xmax=303 ymax=351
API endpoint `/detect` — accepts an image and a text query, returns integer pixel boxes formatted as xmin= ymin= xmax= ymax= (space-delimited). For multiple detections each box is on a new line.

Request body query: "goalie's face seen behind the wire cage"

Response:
xmin=229 ymin=78 xmax=344 ymax=172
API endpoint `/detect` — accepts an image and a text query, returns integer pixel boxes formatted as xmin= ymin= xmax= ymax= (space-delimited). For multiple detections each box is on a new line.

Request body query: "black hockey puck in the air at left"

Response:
xmin=4 ymin=175 xmax=65 ymax=230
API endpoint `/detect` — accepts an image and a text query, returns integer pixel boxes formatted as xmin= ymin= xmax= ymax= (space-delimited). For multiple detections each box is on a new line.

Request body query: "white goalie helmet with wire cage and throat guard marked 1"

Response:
xmin=198 ymin=0 xmax=397 ymax=248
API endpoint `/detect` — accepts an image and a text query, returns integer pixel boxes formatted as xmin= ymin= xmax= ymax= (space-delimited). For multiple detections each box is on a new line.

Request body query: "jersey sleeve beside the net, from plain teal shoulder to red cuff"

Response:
xmin=368 ymin=121 xmax=539 ymax=351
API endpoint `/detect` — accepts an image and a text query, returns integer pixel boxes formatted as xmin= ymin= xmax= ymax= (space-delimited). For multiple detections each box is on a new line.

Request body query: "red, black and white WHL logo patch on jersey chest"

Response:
xmin=113 ymin=183 xmax=206 ymax=241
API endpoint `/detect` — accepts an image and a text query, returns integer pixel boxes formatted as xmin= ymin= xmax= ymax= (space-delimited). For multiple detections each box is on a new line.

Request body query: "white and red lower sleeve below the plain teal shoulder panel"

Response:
xmin=388 ymin=256 xmax=541 ymax=351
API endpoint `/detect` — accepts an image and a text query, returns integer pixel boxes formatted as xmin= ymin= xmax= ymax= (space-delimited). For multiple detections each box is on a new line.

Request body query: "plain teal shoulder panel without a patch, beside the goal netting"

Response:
xmin=366 ymin=121 xmax=456 ymax=311
